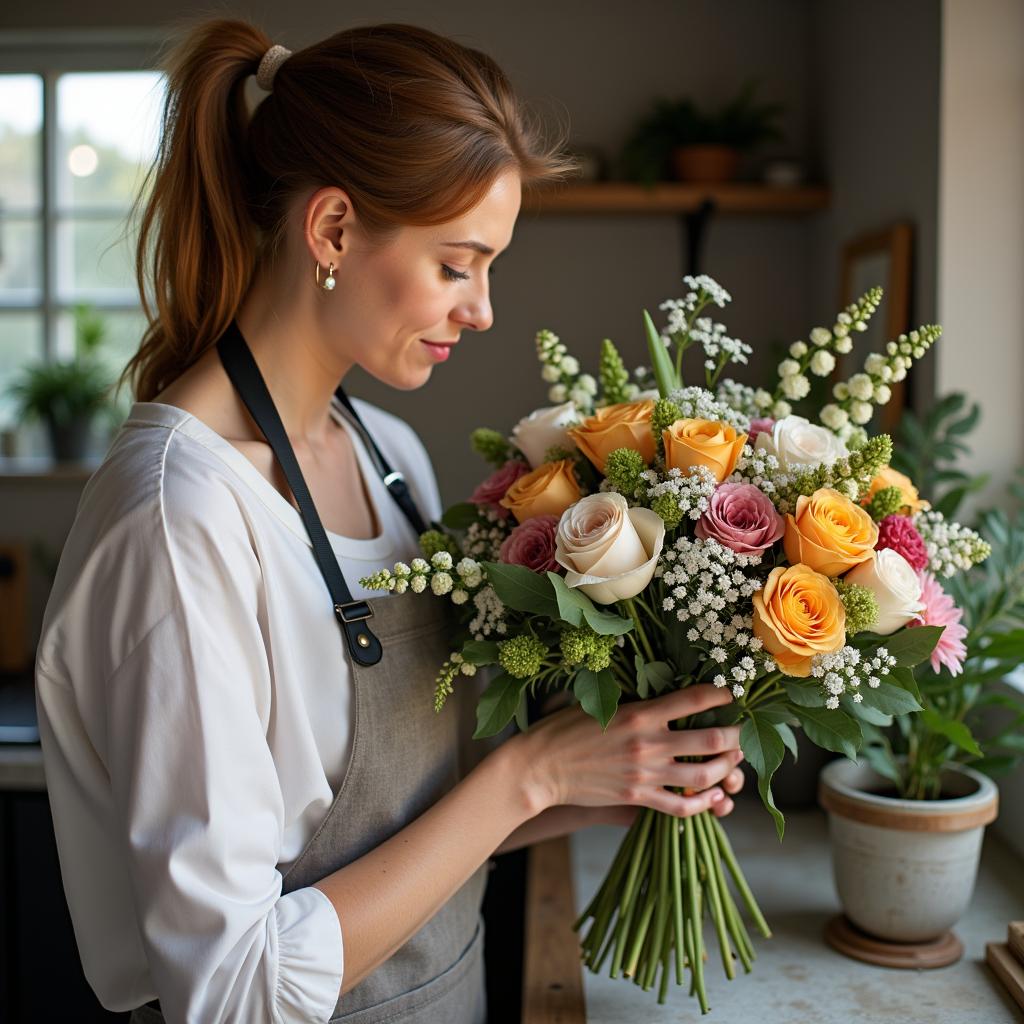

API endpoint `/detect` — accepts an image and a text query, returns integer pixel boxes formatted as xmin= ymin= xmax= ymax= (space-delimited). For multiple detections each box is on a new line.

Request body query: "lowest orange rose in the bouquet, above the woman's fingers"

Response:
xmin=754 ymin=565 xmax=846 ymax=678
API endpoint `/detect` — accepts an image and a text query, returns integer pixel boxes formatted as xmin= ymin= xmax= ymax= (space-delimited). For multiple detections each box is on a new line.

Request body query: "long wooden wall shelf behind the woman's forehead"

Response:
xmin=523 ymin=181 xmax=829 ymax=215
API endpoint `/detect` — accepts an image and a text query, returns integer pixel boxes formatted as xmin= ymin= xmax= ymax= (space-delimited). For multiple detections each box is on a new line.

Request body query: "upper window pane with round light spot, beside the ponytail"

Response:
xmin=56 ymin=72 xmax=164 ymax=209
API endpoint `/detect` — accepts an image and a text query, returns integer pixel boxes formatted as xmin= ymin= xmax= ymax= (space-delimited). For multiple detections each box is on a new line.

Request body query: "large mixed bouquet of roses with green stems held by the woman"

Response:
xmin=360 ymin=276 xmax=987 ymax=1012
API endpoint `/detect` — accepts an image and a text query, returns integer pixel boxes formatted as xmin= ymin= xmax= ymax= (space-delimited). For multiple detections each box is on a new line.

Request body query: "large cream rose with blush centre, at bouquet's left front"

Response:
xmin=555 ymin=492 xmax=665 ymax=604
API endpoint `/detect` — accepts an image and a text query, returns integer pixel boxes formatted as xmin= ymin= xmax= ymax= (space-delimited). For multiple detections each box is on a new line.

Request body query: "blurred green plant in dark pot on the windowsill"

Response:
xmin=8 ymin=304 xmax=114 ymax=462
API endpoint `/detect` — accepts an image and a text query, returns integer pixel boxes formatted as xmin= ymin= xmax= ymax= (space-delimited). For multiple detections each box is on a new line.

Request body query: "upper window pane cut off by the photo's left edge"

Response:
xmin=0 ymin=75 xmax=43 ymax=217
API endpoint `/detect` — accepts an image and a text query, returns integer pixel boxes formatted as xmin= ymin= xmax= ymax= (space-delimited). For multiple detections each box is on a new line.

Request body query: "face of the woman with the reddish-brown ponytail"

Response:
xmin=318 ymin=171 xmax=521 ymax=390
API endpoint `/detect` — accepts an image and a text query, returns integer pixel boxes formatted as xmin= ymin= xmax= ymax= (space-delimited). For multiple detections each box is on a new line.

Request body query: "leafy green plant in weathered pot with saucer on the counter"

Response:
xmin=819 ymin=394 xmax=1024 ymax=967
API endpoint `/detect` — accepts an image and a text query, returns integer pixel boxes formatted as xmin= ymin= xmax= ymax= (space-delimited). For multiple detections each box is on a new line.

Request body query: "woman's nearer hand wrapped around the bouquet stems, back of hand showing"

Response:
xmin=512 ymin=683 xmax=742 ymax=817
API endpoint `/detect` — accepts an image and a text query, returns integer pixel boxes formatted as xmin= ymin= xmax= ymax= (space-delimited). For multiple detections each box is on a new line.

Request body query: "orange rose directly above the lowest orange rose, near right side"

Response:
xmin=782 ymin=487 xmax=879 ymax=577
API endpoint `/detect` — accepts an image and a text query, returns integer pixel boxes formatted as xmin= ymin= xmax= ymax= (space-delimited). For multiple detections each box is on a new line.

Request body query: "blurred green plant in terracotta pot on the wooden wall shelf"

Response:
xmin=623 ymin=79 xmax=784 ymax=184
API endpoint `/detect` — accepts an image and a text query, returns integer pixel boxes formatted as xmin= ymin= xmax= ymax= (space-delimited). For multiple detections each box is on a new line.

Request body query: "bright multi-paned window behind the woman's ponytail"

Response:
xmin=0 ymin=38 xmax=164 ymax=430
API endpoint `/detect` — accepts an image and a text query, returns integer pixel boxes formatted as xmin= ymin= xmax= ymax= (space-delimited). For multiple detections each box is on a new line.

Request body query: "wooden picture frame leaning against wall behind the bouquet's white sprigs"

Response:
xmin=836 ymin=221 xmax=913 ymax=434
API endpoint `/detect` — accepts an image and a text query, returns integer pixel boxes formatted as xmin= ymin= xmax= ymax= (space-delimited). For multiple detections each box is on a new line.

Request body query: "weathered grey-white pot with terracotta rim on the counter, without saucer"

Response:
xmin=818 ymin=758 xmax=998 ymax=942
